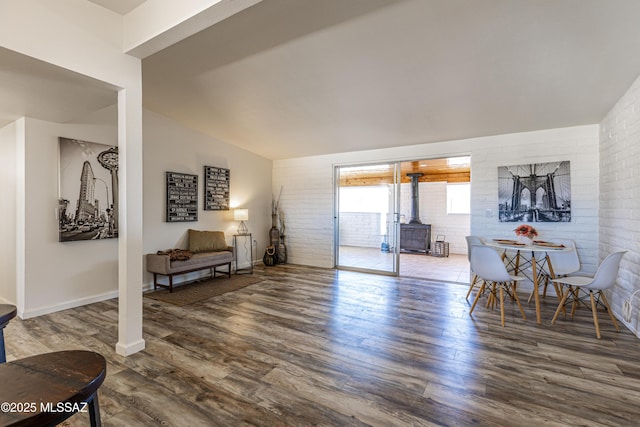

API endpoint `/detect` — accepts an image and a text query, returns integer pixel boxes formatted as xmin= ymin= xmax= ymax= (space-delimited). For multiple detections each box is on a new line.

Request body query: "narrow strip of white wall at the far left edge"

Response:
xmin=0 ymin=122 xmax=17 ymax=305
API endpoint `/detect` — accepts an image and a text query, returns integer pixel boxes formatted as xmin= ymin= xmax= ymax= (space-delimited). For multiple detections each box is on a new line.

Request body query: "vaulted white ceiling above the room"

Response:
xmin=0 ymin=0 xmax=640 ymax=159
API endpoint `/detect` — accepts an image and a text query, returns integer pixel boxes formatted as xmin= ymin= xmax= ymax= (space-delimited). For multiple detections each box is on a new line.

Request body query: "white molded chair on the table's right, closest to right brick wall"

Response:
xmin=551 ymin=251 xmax=627 ymax=339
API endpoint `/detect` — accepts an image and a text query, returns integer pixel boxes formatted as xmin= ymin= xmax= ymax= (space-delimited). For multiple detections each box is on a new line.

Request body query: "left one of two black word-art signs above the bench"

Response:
xmin=165 ymin=172 xmax=198 ymax=222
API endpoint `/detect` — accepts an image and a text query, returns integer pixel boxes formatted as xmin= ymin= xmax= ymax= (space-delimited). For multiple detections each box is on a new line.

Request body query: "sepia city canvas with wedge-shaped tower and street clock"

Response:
xmin=58 ymin=137 xmax=118 ymax=242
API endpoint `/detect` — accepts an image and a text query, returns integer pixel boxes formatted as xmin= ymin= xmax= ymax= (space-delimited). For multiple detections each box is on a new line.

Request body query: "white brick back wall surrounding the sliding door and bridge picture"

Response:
xmin=273 ymin=125 xmax=598 ymax=271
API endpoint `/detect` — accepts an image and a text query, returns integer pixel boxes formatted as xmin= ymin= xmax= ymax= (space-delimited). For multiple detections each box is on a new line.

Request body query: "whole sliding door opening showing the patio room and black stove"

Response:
xmin=335 ymin=156 xmax=470 ymax=283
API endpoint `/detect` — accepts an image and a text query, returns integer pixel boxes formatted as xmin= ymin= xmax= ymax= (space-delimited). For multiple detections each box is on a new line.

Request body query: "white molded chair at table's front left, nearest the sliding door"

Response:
xmin=469 ymin=245 xmax=527 ymax=327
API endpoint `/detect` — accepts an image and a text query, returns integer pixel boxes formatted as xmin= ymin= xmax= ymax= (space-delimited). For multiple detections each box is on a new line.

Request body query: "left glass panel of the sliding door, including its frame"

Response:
xmin=334 ymin=163 xmax=399 ymax=275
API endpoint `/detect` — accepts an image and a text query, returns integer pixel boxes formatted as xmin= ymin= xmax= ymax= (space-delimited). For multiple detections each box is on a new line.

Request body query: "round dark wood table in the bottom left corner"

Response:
xmin=0 ymin=350 xmax=107 ymax=426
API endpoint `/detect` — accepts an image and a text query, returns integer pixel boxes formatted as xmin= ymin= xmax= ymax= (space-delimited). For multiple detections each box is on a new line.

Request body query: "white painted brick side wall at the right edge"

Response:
xmin=600 ymin=72 xmax=640 ymax=336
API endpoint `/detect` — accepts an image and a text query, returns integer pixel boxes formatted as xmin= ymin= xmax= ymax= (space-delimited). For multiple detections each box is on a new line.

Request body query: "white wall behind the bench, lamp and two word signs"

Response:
xmin=144 ymin=110 xmax=272 ymax=283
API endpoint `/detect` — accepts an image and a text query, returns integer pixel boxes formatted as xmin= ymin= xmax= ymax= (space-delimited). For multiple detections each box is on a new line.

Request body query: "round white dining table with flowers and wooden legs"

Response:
xmin=485 ymin=239 xmax=574 ymax=324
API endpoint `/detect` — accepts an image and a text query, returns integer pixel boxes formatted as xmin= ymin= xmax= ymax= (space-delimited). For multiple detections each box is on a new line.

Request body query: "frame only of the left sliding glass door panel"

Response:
xmin=333 ymin=161 xmax=400 ymax=276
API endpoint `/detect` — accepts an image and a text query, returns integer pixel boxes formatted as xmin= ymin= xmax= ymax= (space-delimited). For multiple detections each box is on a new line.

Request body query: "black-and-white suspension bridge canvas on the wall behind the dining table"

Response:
xmin=498 ymin=161 xmax=571 ymax=222
